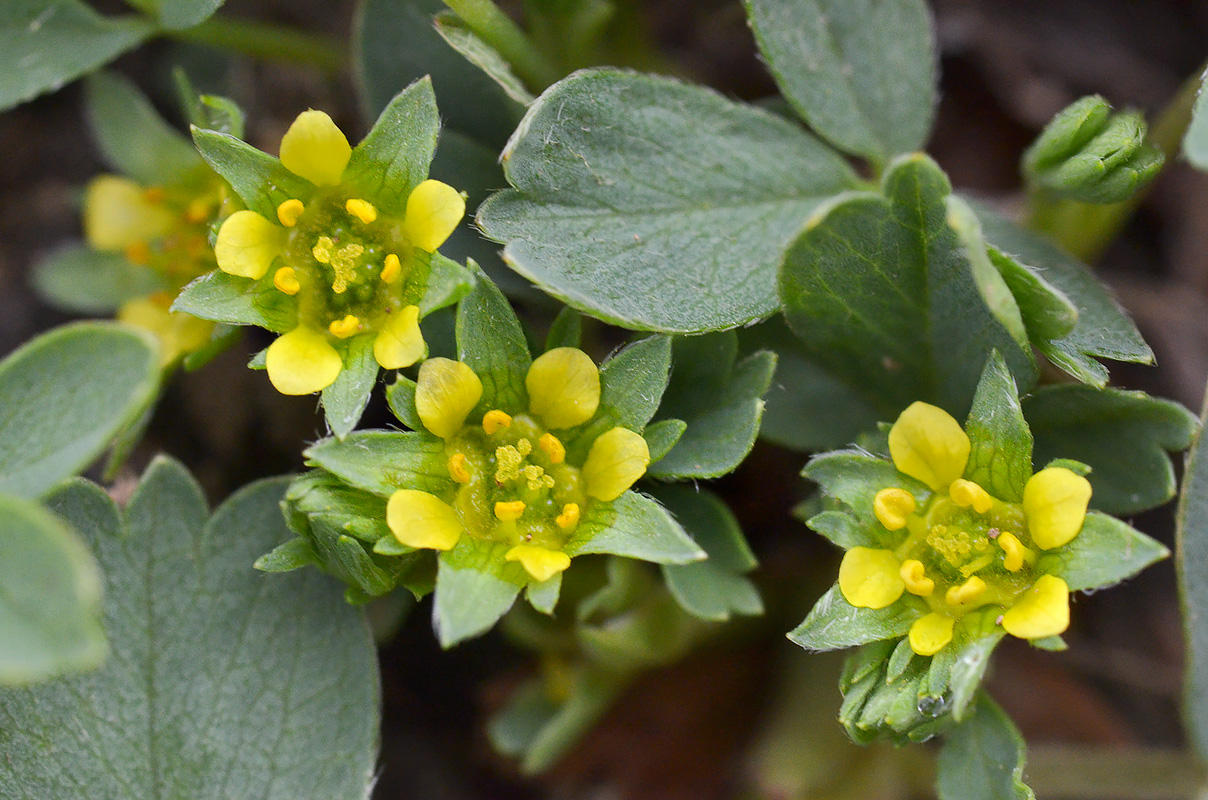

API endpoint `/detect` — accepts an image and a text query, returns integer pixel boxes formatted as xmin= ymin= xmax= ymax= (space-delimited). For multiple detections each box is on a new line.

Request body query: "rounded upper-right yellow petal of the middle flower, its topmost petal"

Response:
xmin=524 ymin=347 xmax=600 ymax=429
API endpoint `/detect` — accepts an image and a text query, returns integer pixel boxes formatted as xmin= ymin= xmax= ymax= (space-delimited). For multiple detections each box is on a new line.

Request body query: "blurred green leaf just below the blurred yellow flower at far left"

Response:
xmin=30 ymin=244 xmax=164 ymax=314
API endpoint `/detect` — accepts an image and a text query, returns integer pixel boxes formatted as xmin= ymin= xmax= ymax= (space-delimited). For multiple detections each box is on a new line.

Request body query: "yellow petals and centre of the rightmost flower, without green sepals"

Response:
xmin=838 ymin=402 xmax=1091 ymax=655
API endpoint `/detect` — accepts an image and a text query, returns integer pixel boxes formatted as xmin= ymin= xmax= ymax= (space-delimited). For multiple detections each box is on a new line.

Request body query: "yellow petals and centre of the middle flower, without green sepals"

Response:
xmin=387 ymin=348 xmax=650 ymax=581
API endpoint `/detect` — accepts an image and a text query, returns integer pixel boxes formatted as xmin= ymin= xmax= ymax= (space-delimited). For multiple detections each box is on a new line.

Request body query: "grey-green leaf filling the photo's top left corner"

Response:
xmin=0 ymin=0 xmax=155 ymax=111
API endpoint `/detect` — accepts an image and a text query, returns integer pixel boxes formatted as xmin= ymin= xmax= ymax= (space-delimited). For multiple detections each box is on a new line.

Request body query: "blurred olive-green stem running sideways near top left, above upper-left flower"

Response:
xmin=163 ymin=17 xmax=345 ymax=73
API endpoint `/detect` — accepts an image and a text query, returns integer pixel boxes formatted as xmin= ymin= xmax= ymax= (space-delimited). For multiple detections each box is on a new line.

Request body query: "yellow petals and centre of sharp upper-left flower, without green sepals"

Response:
xmin=214 ymin=110 xmax=465 ymax=394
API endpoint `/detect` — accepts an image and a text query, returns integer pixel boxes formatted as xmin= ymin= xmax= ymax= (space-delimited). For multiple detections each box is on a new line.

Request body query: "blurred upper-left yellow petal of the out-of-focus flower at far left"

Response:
xmin=83 ymin=175 xmax=176 ymax=250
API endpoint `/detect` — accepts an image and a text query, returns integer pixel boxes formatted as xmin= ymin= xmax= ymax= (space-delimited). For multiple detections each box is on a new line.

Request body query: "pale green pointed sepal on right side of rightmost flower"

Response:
xmin=1041 ymin=511 xmax=1171 ymax=592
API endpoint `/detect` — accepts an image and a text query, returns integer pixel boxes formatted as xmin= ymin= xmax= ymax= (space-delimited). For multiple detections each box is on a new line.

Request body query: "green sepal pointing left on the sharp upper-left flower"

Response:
xmin=172 ymin=269 xmax=298 ymax=334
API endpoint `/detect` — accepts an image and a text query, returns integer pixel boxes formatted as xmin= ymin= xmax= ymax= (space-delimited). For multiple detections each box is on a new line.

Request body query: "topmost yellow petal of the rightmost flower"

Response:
xmin=889 ymin=402 xmax=969 ymax=491
